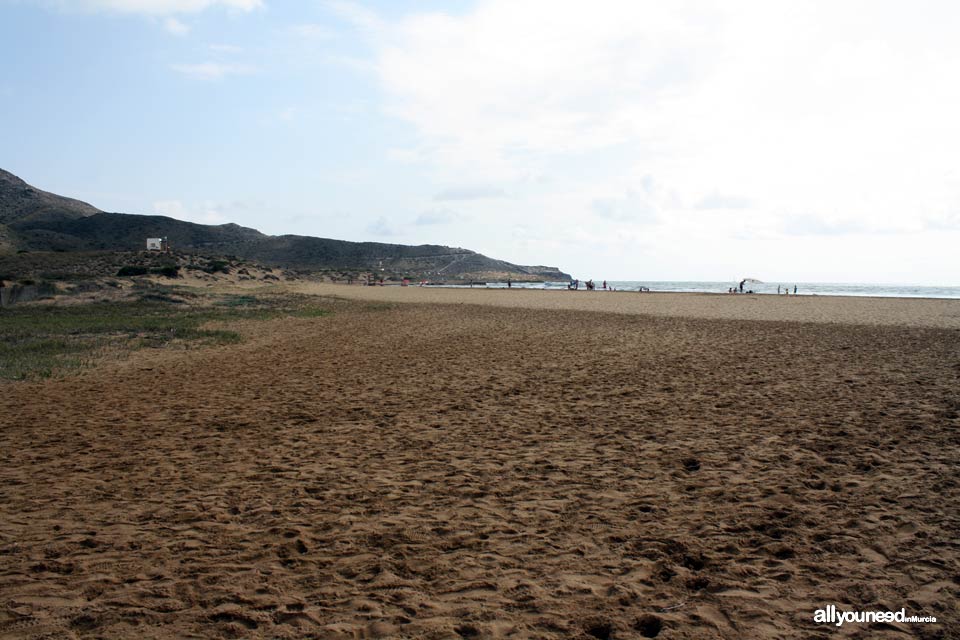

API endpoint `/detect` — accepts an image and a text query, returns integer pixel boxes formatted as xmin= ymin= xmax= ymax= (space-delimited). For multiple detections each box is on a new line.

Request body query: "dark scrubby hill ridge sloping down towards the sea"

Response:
xmin=0 ymin=170 xmax=570 ymax=280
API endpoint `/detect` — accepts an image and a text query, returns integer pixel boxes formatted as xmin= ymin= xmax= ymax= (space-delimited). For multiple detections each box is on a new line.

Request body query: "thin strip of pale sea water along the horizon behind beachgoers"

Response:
xmin=453 ymin=280 xmax=960 ymax=298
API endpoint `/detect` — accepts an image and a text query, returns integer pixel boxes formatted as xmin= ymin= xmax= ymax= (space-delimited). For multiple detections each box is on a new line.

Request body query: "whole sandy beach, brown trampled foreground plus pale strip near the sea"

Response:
xmin=0 ymin=287 xmax=960 ymax=639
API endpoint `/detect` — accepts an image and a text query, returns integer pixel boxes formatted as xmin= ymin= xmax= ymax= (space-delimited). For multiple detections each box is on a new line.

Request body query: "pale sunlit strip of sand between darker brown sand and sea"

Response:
xmin=291 ymin=283 xmax=960 ymax=329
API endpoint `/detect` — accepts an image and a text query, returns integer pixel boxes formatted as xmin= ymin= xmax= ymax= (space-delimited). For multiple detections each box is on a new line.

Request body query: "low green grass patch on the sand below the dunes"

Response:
xmin=0 ymin=287 xmax=330 ymax=380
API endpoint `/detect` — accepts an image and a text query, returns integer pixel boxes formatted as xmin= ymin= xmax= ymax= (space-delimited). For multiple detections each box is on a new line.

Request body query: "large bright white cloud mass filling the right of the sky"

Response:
xmin=360 ymin=0 xmax=960 ymax=276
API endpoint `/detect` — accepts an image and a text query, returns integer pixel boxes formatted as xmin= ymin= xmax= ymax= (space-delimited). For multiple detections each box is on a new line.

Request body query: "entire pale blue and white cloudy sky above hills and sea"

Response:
xmin=0 ymin=0 xmax=960 ymax=285
